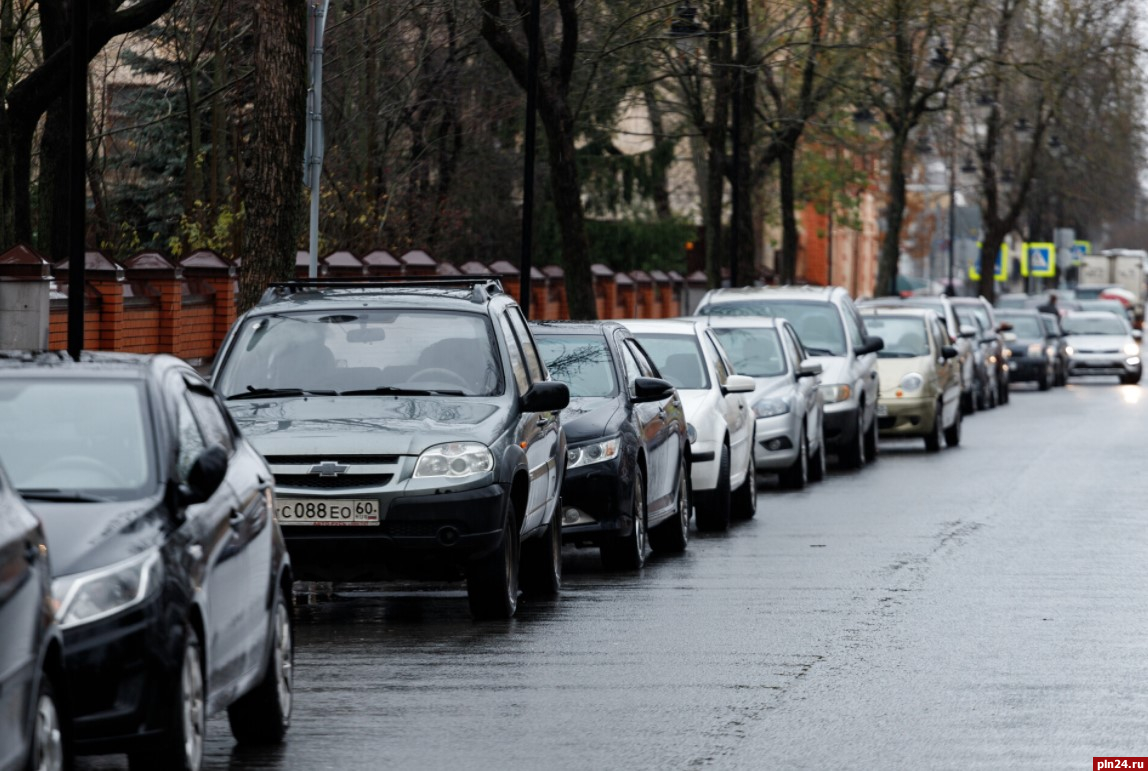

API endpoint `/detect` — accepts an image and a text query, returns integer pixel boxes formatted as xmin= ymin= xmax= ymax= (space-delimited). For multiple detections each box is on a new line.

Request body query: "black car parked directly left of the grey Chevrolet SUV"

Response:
xmin=0 ymin=353 xmax=293 ymax=769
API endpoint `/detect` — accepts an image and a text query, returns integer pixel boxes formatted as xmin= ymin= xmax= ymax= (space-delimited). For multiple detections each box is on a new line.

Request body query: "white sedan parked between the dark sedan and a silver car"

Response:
xmin=622 ymin=319 xmax=758 ymax=530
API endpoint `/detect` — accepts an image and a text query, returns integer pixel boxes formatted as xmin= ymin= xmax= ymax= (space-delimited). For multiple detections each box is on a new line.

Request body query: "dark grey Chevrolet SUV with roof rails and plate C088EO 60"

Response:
xmin=212 ymin=277 xmax=569 ymax=617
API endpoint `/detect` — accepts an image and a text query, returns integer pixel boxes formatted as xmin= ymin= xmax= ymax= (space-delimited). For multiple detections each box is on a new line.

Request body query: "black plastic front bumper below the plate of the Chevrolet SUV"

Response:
xmin=282 ymin=483 xmax=510 ymax=581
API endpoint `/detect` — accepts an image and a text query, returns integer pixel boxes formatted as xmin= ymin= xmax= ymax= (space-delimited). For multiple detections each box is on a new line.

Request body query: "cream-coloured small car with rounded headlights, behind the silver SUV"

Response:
xmin=861 ymin=307 xmax=961 ymax=452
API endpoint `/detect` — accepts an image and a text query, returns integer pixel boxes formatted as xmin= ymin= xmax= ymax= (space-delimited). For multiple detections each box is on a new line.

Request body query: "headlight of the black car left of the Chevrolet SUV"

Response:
xmin=52 ymin=550 xmax=161 ymax=629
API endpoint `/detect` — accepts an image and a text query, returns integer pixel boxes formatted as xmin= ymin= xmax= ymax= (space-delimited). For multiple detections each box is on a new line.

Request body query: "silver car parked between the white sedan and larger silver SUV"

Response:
xmin=705 ymin=317 xmax=825 ymax=490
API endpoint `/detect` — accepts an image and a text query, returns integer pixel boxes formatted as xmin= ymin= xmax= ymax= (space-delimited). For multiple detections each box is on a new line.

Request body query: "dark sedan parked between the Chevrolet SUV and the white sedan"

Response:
xmin=532 ymin=321 xmax=691 ymax=569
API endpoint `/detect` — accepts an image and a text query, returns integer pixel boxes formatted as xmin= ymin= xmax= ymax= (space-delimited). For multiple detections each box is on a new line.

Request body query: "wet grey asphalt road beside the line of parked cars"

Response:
xmin=103 ymin=382 xmax=1148 ymax=771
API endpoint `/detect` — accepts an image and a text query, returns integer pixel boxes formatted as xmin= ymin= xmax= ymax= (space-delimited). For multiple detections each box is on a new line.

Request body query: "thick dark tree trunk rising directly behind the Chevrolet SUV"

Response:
xmin=236 ymin=0 xmax=307 ymax=313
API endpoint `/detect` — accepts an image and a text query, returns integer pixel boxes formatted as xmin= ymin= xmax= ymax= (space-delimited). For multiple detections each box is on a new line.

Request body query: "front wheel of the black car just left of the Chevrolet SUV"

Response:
xmin=127 ymin=625 xmax=207 ymax=771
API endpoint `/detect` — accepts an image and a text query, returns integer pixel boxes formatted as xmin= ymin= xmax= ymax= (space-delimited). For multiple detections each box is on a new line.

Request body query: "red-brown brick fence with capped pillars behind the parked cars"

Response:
xmin=0 ymin=246 xmax=706 ymax=364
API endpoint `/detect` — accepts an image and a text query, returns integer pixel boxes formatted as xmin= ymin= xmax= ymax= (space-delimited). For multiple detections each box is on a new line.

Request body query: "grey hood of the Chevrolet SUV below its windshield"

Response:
xmin=227 ymin=396 xmax=511 ymax=455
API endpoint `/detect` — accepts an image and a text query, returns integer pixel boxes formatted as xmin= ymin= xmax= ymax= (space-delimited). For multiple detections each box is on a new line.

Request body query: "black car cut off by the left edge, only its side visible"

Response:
xmin=0 ymin=461 xmax=65 ymax=771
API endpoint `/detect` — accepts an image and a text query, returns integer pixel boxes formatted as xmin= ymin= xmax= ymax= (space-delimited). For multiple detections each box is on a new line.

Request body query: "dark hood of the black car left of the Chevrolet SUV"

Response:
xmin=29 ymin=497 xmax=172 ymax=577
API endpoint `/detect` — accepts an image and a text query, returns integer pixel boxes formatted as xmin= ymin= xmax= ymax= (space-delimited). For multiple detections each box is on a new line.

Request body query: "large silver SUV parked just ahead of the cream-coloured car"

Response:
xmin=695 ymin=287 xmax=884 ymax=468
